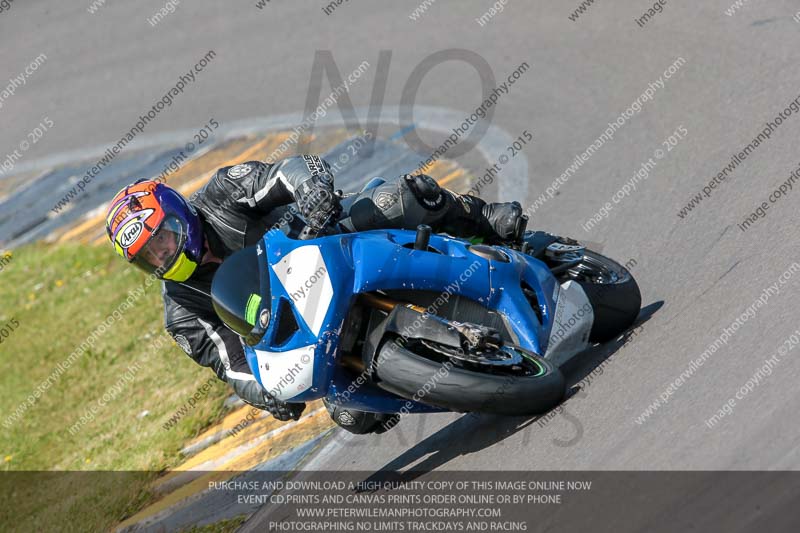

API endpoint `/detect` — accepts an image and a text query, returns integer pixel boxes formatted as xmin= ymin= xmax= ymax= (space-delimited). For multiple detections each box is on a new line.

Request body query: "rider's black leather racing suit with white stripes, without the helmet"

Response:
xmin=162 ymin=156 xmax=521 ymax=432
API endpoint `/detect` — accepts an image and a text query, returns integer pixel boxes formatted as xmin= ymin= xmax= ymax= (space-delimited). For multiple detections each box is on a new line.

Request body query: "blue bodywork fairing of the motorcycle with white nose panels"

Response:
xmin=245 ymin=230 xmax=558 ymax=413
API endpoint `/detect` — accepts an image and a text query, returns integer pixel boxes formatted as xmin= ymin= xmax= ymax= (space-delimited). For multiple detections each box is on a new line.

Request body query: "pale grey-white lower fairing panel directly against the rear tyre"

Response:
xmin=544 ymin=280 xmax=594 ymax=366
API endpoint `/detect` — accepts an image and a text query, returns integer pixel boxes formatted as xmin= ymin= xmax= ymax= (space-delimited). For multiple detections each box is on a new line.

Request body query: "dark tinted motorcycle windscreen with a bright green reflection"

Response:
xmin=211 ymin=246 xmax=270 ymax=346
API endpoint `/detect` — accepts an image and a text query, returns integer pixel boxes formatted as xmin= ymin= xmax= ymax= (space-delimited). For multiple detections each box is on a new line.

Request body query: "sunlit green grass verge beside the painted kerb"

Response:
xmin=0 ymin=244 xmax=236 ymax=531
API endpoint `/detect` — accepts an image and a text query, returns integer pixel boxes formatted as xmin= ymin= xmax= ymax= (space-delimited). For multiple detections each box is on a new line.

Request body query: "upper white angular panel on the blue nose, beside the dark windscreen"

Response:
xmin=272 ymin=245 xmax=333 ymax=335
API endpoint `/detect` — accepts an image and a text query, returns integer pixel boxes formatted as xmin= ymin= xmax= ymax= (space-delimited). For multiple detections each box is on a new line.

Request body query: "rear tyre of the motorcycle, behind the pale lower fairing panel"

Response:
xmin=565 ymin=250 xmax=642 ymax=342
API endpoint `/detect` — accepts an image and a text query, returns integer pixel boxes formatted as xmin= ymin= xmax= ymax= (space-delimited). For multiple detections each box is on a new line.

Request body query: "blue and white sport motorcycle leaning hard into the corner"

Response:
xmin=211 ymin=178 xmax=641 ymax=415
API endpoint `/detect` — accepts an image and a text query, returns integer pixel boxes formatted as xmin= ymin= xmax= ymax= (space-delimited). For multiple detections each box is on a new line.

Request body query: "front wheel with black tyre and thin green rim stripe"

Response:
xmin=376 ymin=337 xmax=566 ymax=415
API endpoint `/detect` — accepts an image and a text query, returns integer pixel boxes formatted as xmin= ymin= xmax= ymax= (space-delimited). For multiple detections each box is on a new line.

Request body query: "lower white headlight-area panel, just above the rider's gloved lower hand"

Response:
xmin=255 ymin=344 xmax=314 ymax=401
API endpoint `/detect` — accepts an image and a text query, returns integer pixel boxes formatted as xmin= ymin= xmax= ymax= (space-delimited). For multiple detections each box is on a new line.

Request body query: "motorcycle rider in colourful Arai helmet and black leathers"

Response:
xmin=106 ymin=155 xmax=522 ymax=433
